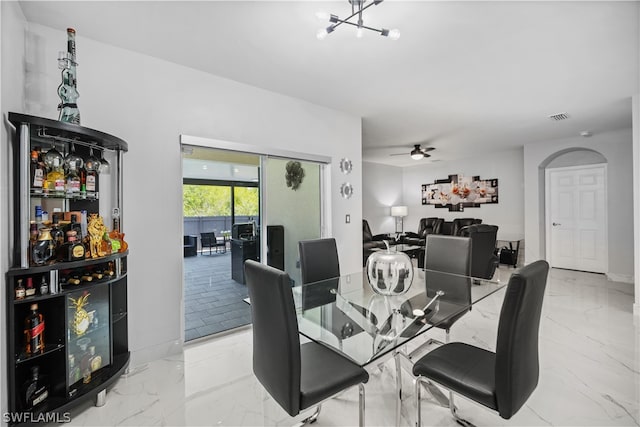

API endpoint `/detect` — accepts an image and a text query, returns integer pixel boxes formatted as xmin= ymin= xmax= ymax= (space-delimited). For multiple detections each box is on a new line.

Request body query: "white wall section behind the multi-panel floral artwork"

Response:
xmin=403 ymin=149 xmax=526 ymax=237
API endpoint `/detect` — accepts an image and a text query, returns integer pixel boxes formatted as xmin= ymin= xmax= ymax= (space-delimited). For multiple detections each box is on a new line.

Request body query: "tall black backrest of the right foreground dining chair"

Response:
xmin=495 ymin=260 xmax=549 ymax=419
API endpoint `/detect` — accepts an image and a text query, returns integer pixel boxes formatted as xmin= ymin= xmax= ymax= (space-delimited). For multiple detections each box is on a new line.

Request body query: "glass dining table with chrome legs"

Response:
xmin=292 ymin=268 xmax=506 ymax=422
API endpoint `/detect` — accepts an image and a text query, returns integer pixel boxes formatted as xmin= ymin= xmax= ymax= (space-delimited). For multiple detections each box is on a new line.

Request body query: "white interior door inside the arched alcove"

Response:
xmin=546 ymin=164 xmax=608 ymax=273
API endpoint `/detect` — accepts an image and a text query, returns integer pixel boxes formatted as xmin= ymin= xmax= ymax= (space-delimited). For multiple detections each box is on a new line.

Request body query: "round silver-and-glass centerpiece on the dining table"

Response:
xmin=367 ymin=240 xmax=413 ymax=295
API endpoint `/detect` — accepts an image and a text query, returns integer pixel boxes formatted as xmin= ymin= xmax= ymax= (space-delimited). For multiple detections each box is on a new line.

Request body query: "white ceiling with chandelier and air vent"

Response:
xmin=21 ymin=0 xmax=640 ymax=166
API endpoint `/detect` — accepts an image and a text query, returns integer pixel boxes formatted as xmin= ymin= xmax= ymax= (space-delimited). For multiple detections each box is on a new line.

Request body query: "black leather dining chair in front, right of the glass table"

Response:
xmin=413 ymin=260 xmax=549 ymax=427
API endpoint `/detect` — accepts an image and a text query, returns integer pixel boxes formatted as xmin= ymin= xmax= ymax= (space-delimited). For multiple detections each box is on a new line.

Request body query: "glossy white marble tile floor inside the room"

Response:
xmin=61 ymin=266 xmax=640 ymax=426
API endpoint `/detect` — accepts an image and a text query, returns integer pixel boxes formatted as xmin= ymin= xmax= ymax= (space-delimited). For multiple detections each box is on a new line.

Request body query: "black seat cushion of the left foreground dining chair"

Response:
xmin=300 ymin=342 xmax=369 ymax=410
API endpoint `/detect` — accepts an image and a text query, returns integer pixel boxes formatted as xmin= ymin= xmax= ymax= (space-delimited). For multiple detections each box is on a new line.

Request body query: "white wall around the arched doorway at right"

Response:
xmin=524 ymin=129 xmax=634 ymax=282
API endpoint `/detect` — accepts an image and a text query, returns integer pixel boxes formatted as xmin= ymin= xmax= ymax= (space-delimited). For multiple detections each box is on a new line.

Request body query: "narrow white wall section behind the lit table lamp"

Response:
xmin=362 ymin=162 xmax=408 ymax=234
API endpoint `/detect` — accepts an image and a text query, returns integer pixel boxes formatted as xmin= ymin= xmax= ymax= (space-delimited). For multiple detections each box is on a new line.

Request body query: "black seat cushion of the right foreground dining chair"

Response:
xmin=413 ymin=342 xmax=498 ymax=410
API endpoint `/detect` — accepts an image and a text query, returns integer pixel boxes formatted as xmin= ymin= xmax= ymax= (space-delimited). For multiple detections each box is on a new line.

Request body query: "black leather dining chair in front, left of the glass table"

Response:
xmin=244 ymin=260 xmax=369 ymax=426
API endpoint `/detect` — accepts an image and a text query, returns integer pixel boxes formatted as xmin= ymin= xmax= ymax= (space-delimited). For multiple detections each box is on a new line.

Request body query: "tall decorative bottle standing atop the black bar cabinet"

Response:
xmin=58 ymin=28 xmax=80 ymax=125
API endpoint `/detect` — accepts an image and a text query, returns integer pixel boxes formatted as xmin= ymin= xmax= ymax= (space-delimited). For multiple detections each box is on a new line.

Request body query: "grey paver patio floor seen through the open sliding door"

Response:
xmin=183 ymin=254 xmax=251 ymax=341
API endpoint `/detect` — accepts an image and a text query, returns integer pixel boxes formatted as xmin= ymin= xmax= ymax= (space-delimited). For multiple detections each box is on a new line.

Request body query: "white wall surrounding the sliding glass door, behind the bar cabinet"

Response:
xmin=2 ymin=15 xmax=362 ymax=378
